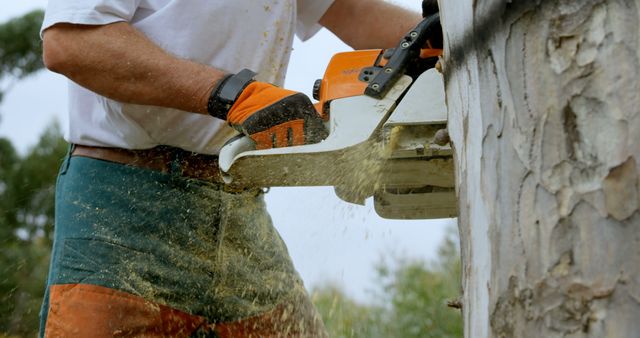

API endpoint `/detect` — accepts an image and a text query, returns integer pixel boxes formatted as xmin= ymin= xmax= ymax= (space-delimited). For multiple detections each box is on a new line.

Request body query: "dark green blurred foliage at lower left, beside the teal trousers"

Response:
xmin=0 ymin=124 xmax=67 ymax=336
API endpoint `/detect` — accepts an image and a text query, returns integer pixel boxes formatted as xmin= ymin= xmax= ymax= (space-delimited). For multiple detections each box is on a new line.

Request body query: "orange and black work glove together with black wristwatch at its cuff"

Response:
xmin=208 ymin=69 xmax=327 ymax=149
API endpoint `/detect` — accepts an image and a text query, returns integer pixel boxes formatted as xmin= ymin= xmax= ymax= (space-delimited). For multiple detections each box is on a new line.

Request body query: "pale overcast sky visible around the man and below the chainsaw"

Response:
xmin=0 ymin=0 xmax=456 ymax=302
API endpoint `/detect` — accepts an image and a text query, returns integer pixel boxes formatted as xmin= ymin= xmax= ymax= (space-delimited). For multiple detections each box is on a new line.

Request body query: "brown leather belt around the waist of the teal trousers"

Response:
xmin=71 ymin=144 xmax=224 ymax=184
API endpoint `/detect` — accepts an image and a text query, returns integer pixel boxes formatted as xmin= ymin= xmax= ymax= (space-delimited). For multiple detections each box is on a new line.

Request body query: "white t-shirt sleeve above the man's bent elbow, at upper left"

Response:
xmin=40 ymin=0 xmax=141 ymax=35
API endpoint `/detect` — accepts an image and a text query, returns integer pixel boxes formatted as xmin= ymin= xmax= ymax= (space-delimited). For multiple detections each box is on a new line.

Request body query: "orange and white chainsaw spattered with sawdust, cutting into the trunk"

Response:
xmin=219 ymin=15 xmax=457 ymax=219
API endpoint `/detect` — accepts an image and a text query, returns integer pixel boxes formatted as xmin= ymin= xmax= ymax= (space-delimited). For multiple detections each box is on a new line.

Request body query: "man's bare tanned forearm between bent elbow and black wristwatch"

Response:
xmin=44 ymin=22 xmax=224 ymax=114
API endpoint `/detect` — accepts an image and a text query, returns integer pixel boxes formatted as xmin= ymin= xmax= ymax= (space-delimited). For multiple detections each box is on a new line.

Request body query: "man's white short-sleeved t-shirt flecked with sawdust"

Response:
xmin=42 ymin=0 xmax=333 ymax=154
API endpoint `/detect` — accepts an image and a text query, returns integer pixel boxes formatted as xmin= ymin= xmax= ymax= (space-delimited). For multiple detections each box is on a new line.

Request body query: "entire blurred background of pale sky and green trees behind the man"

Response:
xmin=0 ymin=0 xmax=462 ymax=337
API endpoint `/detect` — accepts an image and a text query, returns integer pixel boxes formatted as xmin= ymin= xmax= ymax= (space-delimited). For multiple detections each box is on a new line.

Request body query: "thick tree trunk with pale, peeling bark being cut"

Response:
xmin=440 ymin=0 xmax=640 ymax=338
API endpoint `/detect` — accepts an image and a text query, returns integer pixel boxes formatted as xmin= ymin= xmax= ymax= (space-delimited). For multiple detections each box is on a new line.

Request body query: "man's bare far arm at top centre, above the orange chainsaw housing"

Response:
xmin=320 ymin=0 xmax=422 ymax=49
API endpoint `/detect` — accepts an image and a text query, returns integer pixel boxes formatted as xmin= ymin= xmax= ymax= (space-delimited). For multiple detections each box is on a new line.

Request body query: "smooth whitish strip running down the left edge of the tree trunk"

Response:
xmin=441 ymin=1 xmax=491 ymax=337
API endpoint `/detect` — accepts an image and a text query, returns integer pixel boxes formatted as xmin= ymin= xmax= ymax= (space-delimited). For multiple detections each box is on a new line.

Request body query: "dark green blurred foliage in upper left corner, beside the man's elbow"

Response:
xmin=0 ymin=10 xmax=44 ymax=101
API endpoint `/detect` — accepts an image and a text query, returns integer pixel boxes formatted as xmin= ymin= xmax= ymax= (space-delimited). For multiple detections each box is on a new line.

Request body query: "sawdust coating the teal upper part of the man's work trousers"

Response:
xmin=56 ymin=158 xmax=322 ymax=332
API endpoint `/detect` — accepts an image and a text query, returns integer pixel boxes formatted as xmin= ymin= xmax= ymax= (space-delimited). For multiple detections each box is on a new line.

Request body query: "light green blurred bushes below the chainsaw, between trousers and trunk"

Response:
xmin=313 ymin=226 xmax=463 ymax=338
